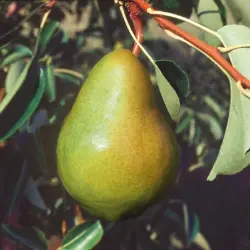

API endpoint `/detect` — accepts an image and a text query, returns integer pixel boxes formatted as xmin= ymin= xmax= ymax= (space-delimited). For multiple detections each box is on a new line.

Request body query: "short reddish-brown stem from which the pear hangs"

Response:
xmin=125 ymin=2 xmax=143 ymax=56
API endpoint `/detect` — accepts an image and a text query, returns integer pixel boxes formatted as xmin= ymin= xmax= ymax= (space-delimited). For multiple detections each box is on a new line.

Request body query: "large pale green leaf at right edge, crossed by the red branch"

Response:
xmin=207 ymin=25 xmax=250 ymax=181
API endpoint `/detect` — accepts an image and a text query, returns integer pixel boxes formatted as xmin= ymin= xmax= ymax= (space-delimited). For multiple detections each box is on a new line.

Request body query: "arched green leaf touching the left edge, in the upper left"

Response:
xmin=0 ymin=45 xmax=32 ymax=68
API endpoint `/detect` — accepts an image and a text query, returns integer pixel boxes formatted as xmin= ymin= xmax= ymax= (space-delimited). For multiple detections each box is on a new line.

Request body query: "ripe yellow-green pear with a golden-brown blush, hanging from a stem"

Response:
xmin=57 ymin=49 xmax=179 ymax=221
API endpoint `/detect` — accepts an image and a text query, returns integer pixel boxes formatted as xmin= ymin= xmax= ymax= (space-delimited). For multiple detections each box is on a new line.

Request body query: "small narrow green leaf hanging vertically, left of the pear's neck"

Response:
xmin=43 ymin=60 xmax=56 ymax=102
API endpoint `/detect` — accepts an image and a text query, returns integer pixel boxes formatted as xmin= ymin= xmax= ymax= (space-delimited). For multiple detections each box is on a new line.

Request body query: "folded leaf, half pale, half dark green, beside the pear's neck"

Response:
xmin=155 ymin=60 xmax=189 ymax=122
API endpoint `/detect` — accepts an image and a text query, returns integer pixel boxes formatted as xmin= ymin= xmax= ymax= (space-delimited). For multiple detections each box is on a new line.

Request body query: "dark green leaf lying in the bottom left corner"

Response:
xmin=2 ymin=224 xmax=47 ymax=250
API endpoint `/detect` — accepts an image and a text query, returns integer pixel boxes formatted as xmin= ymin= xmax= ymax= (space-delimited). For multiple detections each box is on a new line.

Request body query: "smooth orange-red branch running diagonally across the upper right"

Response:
xmin=130 ymin=0 xmax=250 ymax=89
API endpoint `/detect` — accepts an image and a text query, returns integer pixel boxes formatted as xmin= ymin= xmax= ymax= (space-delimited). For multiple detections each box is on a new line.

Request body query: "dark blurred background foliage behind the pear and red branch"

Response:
xmin=0 ymin=0 xmax=250 ymax=250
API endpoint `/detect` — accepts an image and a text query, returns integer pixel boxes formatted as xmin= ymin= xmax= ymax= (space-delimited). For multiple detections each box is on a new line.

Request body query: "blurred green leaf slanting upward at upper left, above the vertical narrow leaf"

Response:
xmin=38 ymin=20 xmax=59 ymax=54
